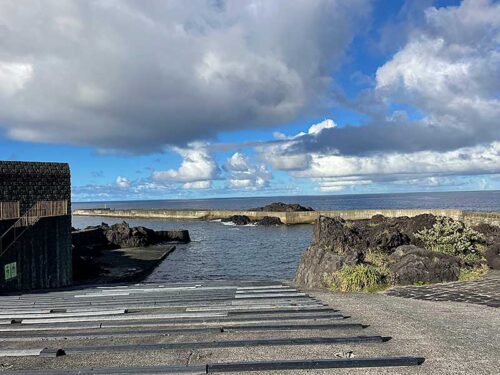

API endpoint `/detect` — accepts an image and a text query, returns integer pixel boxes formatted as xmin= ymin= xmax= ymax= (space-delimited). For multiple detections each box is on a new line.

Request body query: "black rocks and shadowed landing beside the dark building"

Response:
xmin=71 ymin=222 xmax=191 ymax=284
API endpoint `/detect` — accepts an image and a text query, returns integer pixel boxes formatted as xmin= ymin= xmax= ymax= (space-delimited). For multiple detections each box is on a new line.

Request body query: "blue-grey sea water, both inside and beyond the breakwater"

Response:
xmin=73 ymin=191 xmax=500 ymax=282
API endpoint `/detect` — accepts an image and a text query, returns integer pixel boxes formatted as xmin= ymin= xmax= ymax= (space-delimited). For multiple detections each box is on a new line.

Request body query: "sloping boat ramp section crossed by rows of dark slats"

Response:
xmin=0 ymin=281 xmax=424 ymax=374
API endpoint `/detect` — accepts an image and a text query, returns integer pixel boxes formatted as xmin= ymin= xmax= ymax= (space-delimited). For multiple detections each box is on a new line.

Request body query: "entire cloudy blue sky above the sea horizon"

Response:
xmin=0 ymin=0 xmax=500 ymax=201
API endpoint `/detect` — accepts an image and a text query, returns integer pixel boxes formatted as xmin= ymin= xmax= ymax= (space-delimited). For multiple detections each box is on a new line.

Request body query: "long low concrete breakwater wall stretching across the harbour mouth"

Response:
xmin=73 ymin=209 xmax=500 ymax=226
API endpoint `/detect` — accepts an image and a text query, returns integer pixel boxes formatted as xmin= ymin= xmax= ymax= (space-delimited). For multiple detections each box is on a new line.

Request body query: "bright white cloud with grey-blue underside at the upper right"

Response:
xmin=282 ymin=0 xmax=500 ymax=155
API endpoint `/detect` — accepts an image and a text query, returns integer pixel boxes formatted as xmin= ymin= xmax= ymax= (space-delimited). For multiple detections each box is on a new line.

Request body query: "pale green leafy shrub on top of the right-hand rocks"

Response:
xmin=415 ymin=217 xmax=484 ymax=257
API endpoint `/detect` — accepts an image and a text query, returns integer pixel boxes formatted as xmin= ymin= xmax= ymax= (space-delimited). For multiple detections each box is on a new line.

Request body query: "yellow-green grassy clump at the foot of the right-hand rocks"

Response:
xmin=327 ymin=264 xmax=387 ymax=292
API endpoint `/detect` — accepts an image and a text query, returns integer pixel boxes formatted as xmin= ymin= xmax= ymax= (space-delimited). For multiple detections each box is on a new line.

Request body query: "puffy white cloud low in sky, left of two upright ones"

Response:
xmin=152 ymin=142 xmax=219 ymax=189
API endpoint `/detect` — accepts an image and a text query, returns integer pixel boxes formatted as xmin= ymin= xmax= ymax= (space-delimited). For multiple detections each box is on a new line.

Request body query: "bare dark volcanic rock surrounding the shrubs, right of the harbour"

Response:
xmin=295 ymin=215 xmax=482 ymax=288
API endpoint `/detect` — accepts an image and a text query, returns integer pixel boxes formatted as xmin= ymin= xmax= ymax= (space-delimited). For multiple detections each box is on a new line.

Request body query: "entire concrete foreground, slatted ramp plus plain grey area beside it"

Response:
xmin=0 ymin=282 xmax=500 ymax=374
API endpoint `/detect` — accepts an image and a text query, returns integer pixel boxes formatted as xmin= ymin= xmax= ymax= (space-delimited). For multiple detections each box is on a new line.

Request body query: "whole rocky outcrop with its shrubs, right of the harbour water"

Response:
xmin=295 ymin=215 xmax=500 ymax=291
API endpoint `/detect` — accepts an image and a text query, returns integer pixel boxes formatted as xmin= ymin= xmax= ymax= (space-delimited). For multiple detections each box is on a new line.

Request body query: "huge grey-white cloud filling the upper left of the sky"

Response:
xmin=0 ymin=0 xmax=370 ymax=152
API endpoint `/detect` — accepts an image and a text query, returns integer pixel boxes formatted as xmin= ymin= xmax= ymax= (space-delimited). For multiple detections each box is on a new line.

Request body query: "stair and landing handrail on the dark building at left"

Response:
xmin=0 ymin=200 xmax=68 ymax=257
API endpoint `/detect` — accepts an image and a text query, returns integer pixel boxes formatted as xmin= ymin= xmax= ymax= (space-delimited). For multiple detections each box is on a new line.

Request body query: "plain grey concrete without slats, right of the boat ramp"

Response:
xmin=314 ymin=292 xmax=500 ymax=375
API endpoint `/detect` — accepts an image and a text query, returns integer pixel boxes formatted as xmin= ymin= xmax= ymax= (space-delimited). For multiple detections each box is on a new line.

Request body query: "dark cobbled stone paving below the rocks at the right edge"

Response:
xmin=385 ymin=271 xmax=500 ymax=307
